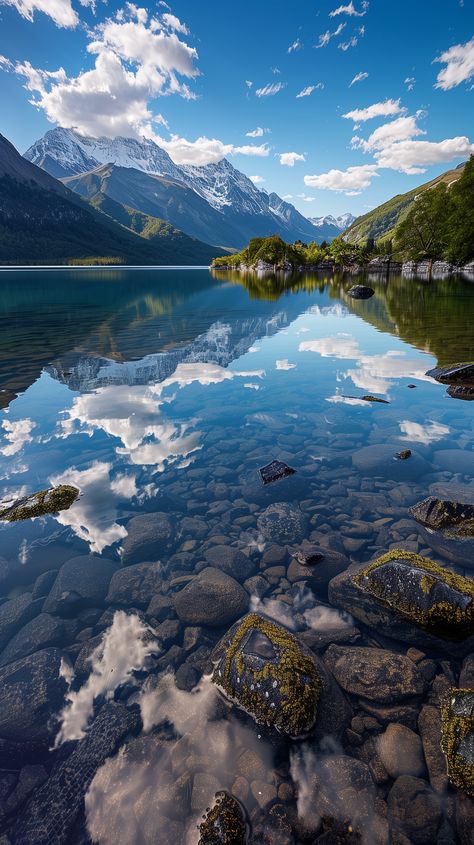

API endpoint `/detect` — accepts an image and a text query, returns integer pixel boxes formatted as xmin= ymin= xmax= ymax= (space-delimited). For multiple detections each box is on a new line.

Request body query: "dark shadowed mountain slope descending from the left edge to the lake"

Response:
xmin=0 ymin=135 xmax=215 ymax=264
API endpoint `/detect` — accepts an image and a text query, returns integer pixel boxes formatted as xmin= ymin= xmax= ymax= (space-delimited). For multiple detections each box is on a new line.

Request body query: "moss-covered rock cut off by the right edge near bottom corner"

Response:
xmin=441 ymin=689 xmax=474 ymax=798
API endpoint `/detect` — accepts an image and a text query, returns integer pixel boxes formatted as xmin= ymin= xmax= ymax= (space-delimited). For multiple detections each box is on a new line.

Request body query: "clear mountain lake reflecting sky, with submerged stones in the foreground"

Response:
xmin=0 ymin=269 xmax=474 ymax=845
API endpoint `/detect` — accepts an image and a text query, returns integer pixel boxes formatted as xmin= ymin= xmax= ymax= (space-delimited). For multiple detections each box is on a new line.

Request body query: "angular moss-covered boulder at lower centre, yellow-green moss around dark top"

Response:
xmin=212 ymin=613 xmax=322 ymax=737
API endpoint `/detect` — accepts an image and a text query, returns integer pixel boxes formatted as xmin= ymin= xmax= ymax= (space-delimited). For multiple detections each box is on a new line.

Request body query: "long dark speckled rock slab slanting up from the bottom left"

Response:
xmin=12 ymin=703 xmax=141 ymax=845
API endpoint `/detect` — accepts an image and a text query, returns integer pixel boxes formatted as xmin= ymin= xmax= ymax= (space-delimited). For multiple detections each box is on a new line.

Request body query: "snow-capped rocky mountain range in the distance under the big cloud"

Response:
xmin=25 ymin=128 xmax=318 ymax=249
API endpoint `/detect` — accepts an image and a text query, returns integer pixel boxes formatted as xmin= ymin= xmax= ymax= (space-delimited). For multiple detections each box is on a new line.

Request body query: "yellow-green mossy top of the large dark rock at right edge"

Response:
xmin=352 ymin=549 xmax=474 ymax=639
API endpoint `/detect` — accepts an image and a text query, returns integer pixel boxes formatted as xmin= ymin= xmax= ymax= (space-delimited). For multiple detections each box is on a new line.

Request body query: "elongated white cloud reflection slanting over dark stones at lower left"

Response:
xmin=55 ymin=610 xmax=158 ymax=747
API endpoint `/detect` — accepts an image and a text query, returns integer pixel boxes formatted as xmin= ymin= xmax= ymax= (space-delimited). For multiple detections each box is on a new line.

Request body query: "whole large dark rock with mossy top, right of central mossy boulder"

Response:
xmin=328 ymin=549 xmax=474 ymax=654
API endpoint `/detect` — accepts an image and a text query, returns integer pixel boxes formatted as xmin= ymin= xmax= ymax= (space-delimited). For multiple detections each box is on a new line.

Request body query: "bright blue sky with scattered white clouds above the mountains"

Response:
xmin=0 ymin=0 xmax=474 ymax=217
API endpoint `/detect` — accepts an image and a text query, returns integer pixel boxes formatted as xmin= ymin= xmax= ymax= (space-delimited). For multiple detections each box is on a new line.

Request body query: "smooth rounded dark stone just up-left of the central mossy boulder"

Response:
xmin=174 ymin=567 xmax=249 ymax=627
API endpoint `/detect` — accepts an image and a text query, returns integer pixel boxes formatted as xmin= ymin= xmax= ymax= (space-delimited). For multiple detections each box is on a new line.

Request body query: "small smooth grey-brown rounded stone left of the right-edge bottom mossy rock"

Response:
xmin=376 ymin=723 xmax=425 ymax=778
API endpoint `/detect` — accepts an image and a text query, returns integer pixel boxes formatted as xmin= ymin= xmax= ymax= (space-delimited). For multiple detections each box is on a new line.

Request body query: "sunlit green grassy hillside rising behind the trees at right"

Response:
xmin=344 ymin=163 xmax=465 ymax=244
